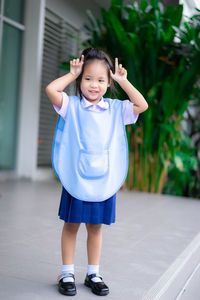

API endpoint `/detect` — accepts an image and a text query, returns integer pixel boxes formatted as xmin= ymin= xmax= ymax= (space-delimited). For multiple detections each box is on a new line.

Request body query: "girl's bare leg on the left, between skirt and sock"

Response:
xmin=61 ymin=223 xmax=80 ymax=265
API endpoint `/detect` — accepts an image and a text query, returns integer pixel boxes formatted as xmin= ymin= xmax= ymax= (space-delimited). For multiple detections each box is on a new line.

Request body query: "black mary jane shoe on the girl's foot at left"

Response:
xmin=57 ymin=273 xmax=76 ymax=296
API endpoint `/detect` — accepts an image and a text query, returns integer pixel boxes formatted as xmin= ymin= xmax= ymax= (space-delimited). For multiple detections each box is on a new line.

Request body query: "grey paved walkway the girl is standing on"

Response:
xmin=0 ymin=180 xmax=200 ymax=300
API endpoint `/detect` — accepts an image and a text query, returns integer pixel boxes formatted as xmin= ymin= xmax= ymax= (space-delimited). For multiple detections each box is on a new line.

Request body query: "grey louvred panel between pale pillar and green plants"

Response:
xmin=38 ymin=9 xmax=78 ymax=167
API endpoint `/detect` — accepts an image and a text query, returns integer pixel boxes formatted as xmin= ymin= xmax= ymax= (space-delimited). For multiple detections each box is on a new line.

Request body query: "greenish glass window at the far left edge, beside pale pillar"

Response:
xmin=0 ymin=0 xmax=24 ymax=170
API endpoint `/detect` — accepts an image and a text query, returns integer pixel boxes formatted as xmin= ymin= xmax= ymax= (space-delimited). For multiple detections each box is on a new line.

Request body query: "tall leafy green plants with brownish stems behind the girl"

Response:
xmin=84 ymin=0 xmax=200 ymax=194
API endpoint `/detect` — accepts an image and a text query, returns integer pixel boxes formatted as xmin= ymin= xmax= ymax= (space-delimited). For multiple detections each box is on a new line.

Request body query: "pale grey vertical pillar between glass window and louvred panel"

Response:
xmin=16 ymin=0 xmax=45 ymax=179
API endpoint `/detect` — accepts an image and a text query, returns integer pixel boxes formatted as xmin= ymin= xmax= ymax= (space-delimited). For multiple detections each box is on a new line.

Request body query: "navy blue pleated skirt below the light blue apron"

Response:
xmin=58 ymin=187 xmax=116 ymax=225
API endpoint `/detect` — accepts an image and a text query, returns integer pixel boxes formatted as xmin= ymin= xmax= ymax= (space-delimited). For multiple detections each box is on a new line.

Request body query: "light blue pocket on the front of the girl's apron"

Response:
xmin=78 ymin=150 xmax=109 ymax=179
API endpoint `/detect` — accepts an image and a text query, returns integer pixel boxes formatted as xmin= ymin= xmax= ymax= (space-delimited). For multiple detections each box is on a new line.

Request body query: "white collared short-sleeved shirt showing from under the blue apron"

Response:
xmin=53 ymin=92 xmax=139 ymax=125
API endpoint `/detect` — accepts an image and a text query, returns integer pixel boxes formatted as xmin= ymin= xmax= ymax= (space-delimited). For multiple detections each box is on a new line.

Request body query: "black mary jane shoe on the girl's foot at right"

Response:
xmin=84 ymin=274 xmax=109 ymax=296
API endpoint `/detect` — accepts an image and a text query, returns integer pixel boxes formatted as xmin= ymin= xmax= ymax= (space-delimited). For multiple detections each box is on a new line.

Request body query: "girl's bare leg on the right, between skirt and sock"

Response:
xmin=86 ymin=224 xmax=102 ymax=265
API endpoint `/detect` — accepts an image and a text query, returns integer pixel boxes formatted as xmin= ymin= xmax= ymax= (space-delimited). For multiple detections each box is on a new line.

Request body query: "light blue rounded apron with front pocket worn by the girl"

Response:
xmin=52 ymin=96 xmax=128 ymax=202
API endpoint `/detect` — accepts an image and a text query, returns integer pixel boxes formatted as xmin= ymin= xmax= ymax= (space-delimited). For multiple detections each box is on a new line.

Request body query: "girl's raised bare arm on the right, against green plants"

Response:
xmin=110 ymin=58 xmax=148 ymax=114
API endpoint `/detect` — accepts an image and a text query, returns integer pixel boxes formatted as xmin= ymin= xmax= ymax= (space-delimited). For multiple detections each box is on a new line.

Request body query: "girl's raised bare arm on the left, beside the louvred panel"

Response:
xmin=45 ymin=55 xmax=84 ymax=108
